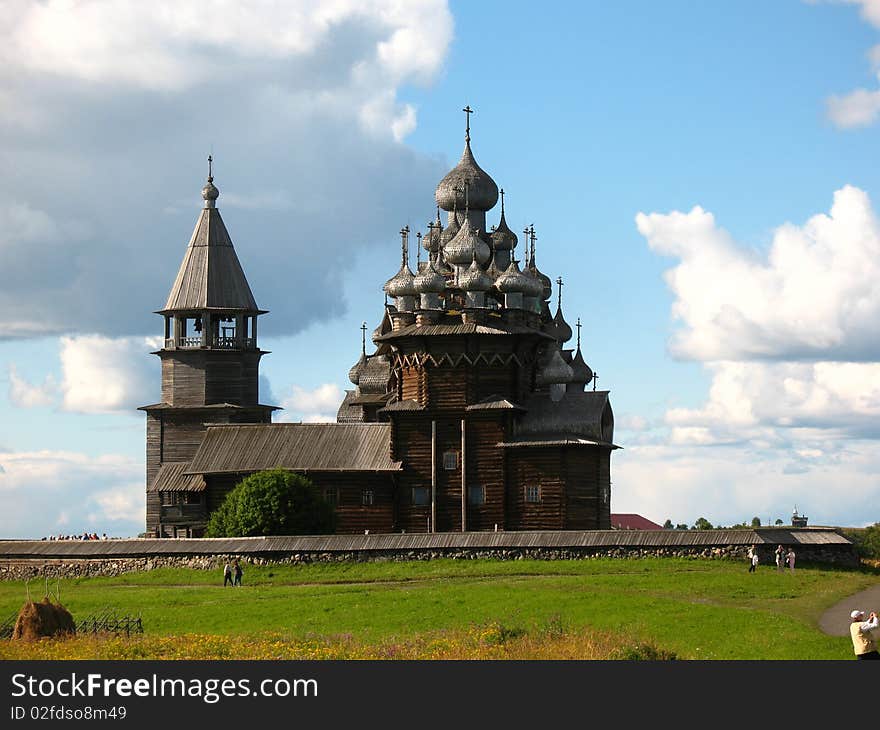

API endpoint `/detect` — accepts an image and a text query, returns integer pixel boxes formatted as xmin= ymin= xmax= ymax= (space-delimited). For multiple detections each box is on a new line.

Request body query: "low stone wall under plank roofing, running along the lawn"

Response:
xmin=0 ymin=544 xmax=859 ymax=580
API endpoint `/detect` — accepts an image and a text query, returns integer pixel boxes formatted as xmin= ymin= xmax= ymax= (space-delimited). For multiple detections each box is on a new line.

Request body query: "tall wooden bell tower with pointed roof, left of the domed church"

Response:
xmin=139 ymin=157 xmax=276 ymax=537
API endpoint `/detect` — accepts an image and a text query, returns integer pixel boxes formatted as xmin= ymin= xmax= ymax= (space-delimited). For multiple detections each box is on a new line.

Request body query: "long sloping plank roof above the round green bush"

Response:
xmin=188 ymin=423 xmax=401 ymax=474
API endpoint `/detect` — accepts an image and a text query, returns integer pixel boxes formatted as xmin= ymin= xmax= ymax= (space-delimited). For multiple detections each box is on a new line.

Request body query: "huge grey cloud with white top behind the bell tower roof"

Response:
xmin=0 ymin=0 xmax=452 ymax=338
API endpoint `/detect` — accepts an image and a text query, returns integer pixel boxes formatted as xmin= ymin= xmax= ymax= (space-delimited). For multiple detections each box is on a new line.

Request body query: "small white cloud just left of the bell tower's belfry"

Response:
xmin=61 ymin=335 xmax=161 ymax=413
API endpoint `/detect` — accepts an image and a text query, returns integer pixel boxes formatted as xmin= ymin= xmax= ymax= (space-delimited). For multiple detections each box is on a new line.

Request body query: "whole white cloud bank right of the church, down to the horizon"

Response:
xmin=613 ymin=186 xmax=880 ymax=525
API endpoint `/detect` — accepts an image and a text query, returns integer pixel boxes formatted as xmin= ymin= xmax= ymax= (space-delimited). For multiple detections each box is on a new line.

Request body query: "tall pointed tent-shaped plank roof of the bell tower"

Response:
xmin=160 ymin=208 xmax=261 ymax=314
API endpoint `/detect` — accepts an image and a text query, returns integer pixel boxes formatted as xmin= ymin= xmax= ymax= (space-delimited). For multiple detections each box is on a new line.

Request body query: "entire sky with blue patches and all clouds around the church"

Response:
xmin=0 ymin=0 xmax=880 ymax=537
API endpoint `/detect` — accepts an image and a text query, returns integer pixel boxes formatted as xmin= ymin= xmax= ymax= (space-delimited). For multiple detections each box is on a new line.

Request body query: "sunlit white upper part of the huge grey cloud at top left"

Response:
xmin=0 ymin=0 xmax=452 ymax=139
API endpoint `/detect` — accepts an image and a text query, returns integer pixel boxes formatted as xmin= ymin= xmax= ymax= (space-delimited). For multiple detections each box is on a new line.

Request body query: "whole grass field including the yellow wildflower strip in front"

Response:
xmin=0 ymin=559 xmax=880 ymax=659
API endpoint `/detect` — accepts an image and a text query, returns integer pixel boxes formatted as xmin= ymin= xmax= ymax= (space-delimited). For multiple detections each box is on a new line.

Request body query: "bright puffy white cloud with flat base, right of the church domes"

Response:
xmin=636 ymin=185 xmax=880 ymax=361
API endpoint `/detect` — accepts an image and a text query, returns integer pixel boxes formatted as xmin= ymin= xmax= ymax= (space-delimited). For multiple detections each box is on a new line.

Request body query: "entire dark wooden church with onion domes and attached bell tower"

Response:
xmin=141 ymin=114 xmax=618 ymax=537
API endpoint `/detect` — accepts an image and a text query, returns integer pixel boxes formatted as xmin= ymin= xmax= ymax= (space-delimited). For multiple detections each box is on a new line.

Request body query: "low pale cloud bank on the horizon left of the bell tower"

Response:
xmin=0 ymin=451 xmax=145 ymax=538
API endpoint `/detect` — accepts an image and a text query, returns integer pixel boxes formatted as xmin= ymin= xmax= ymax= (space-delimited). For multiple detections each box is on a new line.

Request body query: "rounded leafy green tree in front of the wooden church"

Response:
xmin=205 ymin=469 xmax=333 ymax=537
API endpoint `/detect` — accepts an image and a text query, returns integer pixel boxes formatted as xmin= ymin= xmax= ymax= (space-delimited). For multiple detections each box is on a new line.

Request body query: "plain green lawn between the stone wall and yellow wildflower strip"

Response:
xmin=0 ymin=559 xmax=880 ymax=659
